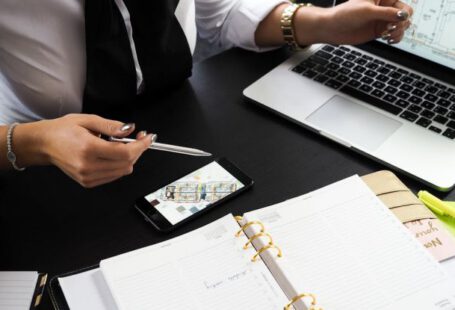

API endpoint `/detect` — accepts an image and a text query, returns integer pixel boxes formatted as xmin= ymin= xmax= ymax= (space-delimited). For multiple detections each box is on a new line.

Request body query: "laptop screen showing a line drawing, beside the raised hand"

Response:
xmin=394 ymin=0 xmax=455 ymax=69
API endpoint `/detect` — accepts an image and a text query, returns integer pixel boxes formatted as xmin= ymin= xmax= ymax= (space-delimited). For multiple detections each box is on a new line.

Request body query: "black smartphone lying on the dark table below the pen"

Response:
xmin=135 ymin=158 xmax=253 ymax=232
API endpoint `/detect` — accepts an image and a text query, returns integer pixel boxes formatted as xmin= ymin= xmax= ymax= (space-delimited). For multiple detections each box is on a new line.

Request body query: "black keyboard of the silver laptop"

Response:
xmin=292 ymin=45 xmax=455 ymax=139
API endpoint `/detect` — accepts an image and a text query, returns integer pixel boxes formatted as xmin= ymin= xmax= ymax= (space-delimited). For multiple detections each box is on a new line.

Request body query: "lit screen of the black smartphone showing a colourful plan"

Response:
xmin=144 ymin=161 xmax=245 ymax=225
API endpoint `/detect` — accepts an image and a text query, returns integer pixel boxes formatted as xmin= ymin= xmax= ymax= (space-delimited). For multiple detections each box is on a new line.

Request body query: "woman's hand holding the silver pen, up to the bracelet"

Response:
xmin=14 ymin=114 xmax=153 ymax=188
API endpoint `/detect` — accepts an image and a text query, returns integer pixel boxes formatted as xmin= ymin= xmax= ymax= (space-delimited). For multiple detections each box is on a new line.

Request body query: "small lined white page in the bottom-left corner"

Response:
xmin=0 ymin=271 xmax=38 ymax=310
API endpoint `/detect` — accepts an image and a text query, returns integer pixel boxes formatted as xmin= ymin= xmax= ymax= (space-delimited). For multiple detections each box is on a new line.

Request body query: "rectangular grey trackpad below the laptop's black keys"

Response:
xmin=306 ymin=95 xmax=402 ymax=151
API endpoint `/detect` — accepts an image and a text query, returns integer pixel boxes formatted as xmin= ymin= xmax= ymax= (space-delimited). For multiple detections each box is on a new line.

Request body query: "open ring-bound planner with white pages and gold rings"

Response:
xmin=50 ymin=176 xmax=455 ymax=310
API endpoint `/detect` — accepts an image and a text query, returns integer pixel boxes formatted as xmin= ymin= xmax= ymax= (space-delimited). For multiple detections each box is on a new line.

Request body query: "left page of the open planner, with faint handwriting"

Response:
xmin=100 ymin=215 xmax=287 ymax=310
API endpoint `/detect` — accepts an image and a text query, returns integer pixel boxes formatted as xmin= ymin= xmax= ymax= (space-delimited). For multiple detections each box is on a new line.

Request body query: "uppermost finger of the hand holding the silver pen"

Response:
xmin=79 ymin=115 xmax=135 ymax=137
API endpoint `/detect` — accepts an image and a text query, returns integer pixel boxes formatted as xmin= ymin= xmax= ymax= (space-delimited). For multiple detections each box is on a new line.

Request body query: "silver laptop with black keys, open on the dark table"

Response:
xmin=244 ymin=0 xmax=455 ymax=191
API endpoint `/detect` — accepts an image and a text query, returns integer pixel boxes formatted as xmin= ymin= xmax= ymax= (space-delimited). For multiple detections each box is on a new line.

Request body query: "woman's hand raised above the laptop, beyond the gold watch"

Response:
xmin=294 ymin=0 xmax=413 ymax=45
